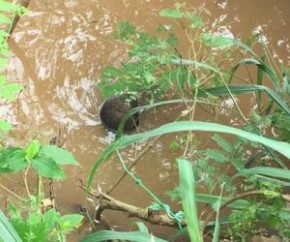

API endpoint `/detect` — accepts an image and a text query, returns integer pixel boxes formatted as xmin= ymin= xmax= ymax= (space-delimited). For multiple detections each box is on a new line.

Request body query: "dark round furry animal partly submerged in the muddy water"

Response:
xmin=100 ymin=94 xmax=139 ymax=132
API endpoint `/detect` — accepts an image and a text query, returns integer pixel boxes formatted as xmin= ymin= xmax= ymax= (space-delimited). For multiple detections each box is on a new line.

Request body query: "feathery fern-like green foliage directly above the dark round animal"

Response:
xmin=98 ymin=19 xmax=178 ymax=100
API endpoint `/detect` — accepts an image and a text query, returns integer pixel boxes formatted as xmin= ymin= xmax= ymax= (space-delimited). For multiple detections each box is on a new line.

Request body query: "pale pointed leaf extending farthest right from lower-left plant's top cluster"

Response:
xmin=39 ymin=145 xmax=78 ymax=165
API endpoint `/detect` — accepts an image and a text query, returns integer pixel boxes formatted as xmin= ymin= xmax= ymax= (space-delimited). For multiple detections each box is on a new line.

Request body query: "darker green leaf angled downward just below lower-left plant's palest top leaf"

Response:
xmin=31 ymin=154 xmax=66 ymax=179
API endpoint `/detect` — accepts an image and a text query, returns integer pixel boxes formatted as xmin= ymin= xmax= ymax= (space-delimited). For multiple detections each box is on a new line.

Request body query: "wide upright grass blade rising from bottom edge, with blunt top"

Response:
xmin=177 ymin=159 xmax=202 ymax=242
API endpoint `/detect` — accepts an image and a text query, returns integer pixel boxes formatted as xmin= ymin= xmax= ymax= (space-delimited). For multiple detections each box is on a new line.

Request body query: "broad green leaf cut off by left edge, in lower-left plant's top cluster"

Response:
xmin=0 ymin=147 xmax=27 ymax=173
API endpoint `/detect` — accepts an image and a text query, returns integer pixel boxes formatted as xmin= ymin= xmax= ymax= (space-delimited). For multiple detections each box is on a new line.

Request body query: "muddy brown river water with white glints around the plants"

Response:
xmin=0 ymin=0 xmax=290 ymax=241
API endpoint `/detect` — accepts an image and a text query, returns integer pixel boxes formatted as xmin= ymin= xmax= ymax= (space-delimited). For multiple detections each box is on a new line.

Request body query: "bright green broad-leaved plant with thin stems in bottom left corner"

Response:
xmin=0 ymin=140 xmax=83 ymax=241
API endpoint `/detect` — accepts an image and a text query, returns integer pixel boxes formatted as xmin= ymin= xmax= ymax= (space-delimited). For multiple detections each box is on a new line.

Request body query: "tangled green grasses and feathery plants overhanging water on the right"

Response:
xmin=83 ymin=4 xmax=290 ymax=241
